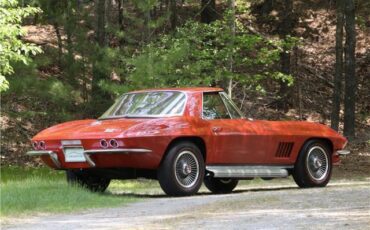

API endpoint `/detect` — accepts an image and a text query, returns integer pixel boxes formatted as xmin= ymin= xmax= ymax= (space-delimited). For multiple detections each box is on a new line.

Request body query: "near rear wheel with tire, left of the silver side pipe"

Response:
xmin=158 ymin=141 xmax=205 ymax=196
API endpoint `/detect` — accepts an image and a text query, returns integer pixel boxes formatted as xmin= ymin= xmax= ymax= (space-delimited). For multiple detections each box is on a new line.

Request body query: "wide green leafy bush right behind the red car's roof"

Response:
xmin=105 ymin=20 xmax=293 ymax=94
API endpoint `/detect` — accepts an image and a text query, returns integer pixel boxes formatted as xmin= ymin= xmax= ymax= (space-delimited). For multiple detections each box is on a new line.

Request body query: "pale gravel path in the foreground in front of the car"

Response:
xmin=2 ymin=182 xmax=370 ymax=230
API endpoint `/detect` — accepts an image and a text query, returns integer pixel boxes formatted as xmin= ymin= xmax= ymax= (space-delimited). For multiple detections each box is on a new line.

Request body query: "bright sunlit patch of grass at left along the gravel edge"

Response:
xmin=0 ymin=177 xmax=137 ymax=216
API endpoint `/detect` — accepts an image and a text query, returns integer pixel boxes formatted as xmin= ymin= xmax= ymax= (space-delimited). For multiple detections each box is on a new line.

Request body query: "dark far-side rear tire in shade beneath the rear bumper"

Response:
xmin=66 ymin=170 xmax=110 ymax=192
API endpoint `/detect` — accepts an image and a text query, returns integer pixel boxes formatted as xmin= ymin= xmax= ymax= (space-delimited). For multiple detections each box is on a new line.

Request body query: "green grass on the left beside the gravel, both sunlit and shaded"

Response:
xmin=0 ymin=167 xmax=153 ymax=217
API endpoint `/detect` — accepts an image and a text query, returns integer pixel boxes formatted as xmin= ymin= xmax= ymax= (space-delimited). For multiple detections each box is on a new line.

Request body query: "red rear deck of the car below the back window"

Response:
xmin=32 ymin=119 xmax=148 ymax=140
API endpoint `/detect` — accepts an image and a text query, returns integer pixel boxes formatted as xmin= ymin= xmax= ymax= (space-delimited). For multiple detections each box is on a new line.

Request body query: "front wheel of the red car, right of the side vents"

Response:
xmin=293 ymin=140 xmax=332 ymax=188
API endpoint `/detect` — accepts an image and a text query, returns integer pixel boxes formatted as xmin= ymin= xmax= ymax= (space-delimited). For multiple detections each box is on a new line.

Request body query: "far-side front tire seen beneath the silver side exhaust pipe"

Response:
xmin=204 ymin=177 xmax=239 ymax=194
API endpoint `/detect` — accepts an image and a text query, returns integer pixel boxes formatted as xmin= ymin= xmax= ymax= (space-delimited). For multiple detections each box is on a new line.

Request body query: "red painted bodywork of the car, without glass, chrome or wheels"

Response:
xmin=32 ymin=88 xmax=346 ymax=169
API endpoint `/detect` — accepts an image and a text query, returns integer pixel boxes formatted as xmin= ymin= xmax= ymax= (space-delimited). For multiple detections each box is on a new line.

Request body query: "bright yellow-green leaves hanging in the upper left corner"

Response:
xmin=0 ymin=0 xmax=41 ymax=92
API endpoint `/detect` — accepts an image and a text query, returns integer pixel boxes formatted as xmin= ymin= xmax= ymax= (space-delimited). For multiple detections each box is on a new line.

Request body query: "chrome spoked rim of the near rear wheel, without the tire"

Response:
xmin=174 ymin=150 xmax=200 ymax=188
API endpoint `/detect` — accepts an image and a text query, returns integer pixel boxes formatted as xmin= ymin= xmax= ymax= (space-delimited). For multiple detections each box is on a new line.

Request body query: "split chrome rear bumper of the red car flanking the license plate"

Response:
xmin=26 ymin=148 xmax=152 ymax=168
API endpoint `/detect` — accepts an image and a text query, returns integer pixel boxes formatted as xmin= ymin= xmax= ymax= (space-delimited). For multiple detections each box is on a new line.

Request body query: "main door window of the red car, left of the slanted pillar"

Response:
xmin=203 ymin=92 xmax=230 ymax=120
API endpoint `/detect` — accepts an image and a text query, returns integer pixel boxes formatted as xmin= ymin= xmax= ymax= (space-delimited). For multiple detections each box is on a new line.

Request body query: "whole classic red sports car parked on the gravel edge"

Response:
xmin=27 ymin=88 xmax=349 ymax=196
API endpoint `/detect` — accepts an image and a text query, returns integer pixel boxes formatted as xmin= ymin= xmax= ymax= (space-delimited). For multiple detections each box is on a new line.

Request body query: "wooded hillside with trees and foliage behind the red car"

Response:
xmin=0 ymin=0 xmax=370 ymax=165
